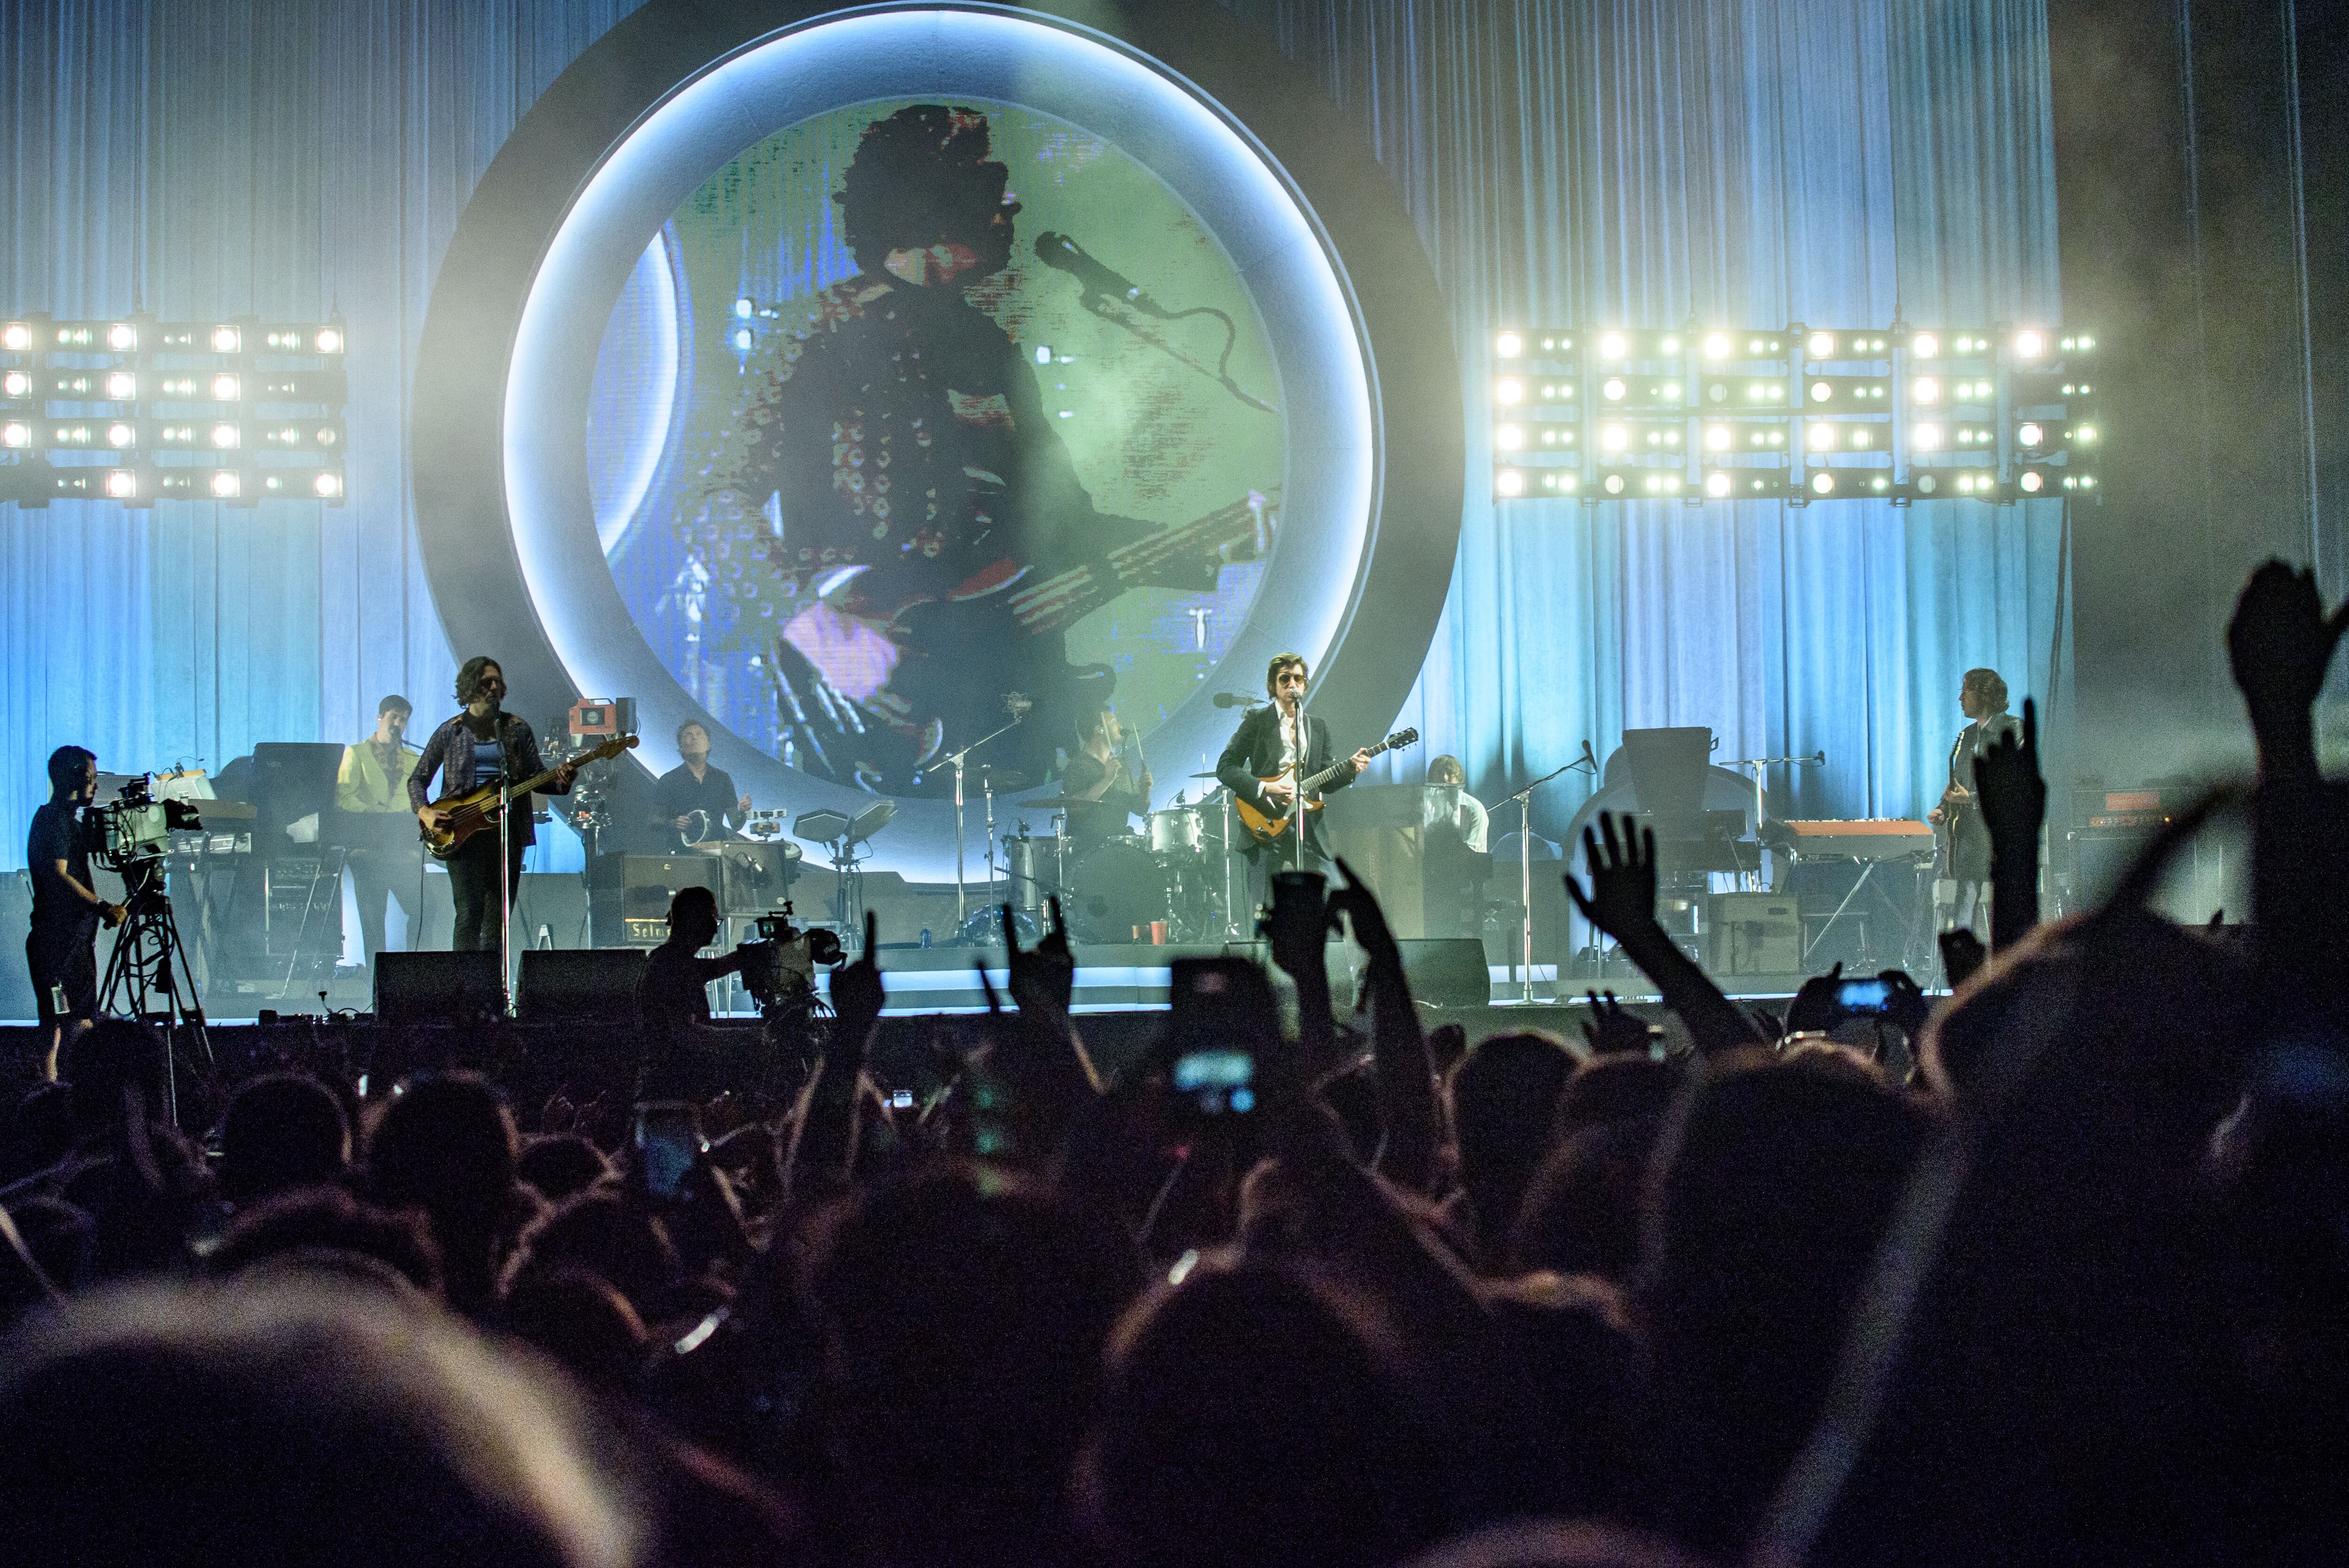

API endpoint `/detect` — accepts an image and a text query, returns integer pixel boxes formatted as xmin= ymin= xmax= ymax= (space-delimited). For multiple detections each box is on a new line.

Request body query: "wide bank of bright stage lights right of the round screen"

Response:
xmin=1492 ymin=322 xmax=2100 ymax=507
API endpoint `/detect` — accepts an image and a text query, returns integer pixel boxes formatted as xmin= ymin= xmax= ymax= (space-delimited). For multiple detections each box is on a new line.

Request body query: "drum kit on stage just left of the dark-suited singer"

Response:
xmin=1003 ymin=775 xmax=1245 ymax=944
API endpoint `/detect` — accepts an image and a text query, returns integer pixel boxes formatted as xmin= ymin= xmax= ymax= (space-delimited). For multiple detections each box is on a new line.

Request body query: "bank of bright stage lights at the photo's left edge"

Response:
xmin=0 ymin=312 xmax=350 ymax=507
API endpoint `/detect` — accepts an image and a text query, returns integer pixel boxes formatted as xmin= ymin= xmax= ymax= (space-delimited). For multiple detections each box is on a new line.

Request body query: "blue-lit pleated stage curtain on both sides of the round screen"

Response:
xmin=0 ymin=0 xmax=2062 ymax=866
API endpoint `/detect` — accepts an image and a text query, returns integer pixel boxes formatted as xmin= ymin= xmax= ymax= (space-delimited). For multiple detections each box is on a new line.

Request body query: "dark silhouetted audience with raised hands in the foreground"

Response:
xmin=0 ymin=563 xmax=2349 ymax=1568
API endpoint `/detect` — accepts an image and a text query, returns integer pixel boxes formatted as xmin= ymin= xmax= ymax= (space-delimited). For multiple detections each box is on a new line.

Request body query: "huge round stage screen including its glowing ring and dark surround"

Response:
xmin=416 ymin=0 xmax=1459 ymax=880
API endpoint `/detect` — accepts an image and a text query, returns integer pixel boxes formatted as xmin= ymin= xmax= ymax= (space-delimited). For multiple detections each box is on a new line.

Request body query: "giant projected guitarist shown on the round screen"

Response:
xmin=677 ymin=103 xmax=1278 ymax=793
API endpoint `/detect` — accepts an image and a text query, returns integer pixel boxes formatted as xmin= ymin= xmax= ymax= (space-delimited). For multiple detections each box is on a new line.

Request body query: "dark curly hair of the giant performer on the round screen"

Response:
xmin=832 ymin=103 xmax=1010 ymax=270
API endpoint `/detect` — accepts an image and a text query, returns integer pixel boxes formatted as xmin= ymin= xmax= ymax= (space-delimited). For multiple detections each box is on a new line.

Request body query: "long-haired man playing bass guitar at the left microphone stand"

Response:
xmin=409 ymin=655 xmax=578 ymax=953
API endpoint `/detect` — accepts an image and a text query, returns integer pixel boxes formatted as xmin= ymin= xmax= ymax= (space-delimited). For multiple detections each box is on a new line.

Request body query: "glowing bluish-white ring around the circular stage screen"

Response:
xmin=500 ymin=9 xmax=1379 ymax=876
